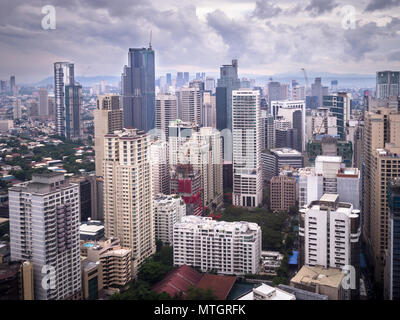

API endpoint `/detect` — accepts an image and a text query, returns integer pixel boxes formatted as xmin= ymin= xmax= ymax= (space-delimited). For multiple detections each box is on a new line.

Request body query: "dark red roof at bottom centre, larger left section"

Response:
xmin=152 ymin=265 xmax=202 ymax=297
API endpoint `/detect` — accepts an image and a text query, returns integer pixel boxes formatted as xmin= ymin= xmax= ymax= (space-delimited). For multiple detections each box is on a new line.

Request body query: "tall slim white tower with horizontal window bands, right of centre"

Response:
xmin=232 ymin=89 xmax=262 ymax=207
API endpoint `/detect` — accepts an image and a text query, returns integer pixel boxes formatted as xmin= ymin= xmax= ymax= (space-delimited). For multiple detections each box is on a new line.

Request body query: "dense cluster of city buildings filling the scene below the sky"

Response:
xmin=0 ymin=45 xmax=400 ymax=300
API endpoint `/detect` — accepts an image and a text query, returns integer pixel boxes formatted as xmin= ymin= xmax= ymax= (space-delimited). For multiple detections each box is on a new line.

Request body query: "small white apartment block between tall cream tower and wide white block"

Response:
xmin=154 ymin=194 xmax=186 ymax=245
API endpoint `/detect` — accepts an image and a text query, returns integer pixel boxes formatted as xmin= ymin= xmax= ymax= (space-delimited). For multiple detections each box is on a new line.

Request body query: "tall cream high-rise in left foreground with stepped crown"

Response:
xmin=103 ymin=129 xmax=155 ymax=277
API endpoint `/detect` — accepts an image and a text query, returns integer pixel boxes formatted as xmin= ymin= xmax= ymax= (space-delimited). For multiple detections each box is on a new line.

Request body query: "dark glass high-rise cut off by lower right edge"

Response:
xmin=384 ymin=178 xmax=400 ymax=300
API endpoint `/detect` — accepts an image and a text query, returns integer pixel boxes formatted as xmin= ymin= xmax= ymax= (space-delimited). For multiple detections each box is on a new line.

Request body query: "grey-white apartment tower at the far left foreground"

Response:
xmin=9 ymin=173 xmax=81 ymax=300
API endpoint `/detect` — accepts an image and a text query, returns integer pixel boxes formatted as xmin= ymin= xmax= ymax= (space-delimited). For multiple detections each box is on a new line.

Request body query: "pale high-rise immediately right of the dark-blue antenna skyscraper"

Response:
xmin=156 ymin=94 xmax=178 ymax=141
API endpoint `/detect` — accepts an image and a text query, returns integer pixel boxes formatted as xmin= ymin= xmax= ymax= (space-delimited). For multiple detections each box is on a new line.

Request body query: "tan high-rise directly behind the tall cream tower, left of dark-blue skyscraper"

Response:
xmin=93 ymin=94 xmax=123 ymax=177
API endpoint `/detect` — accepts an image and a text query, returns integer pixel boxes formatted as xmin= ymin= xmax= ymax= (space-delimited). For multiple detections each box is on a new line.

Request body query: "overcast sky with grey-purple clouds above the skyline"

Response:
xmin=0 ymin=0 xmax=400 ymax=83
